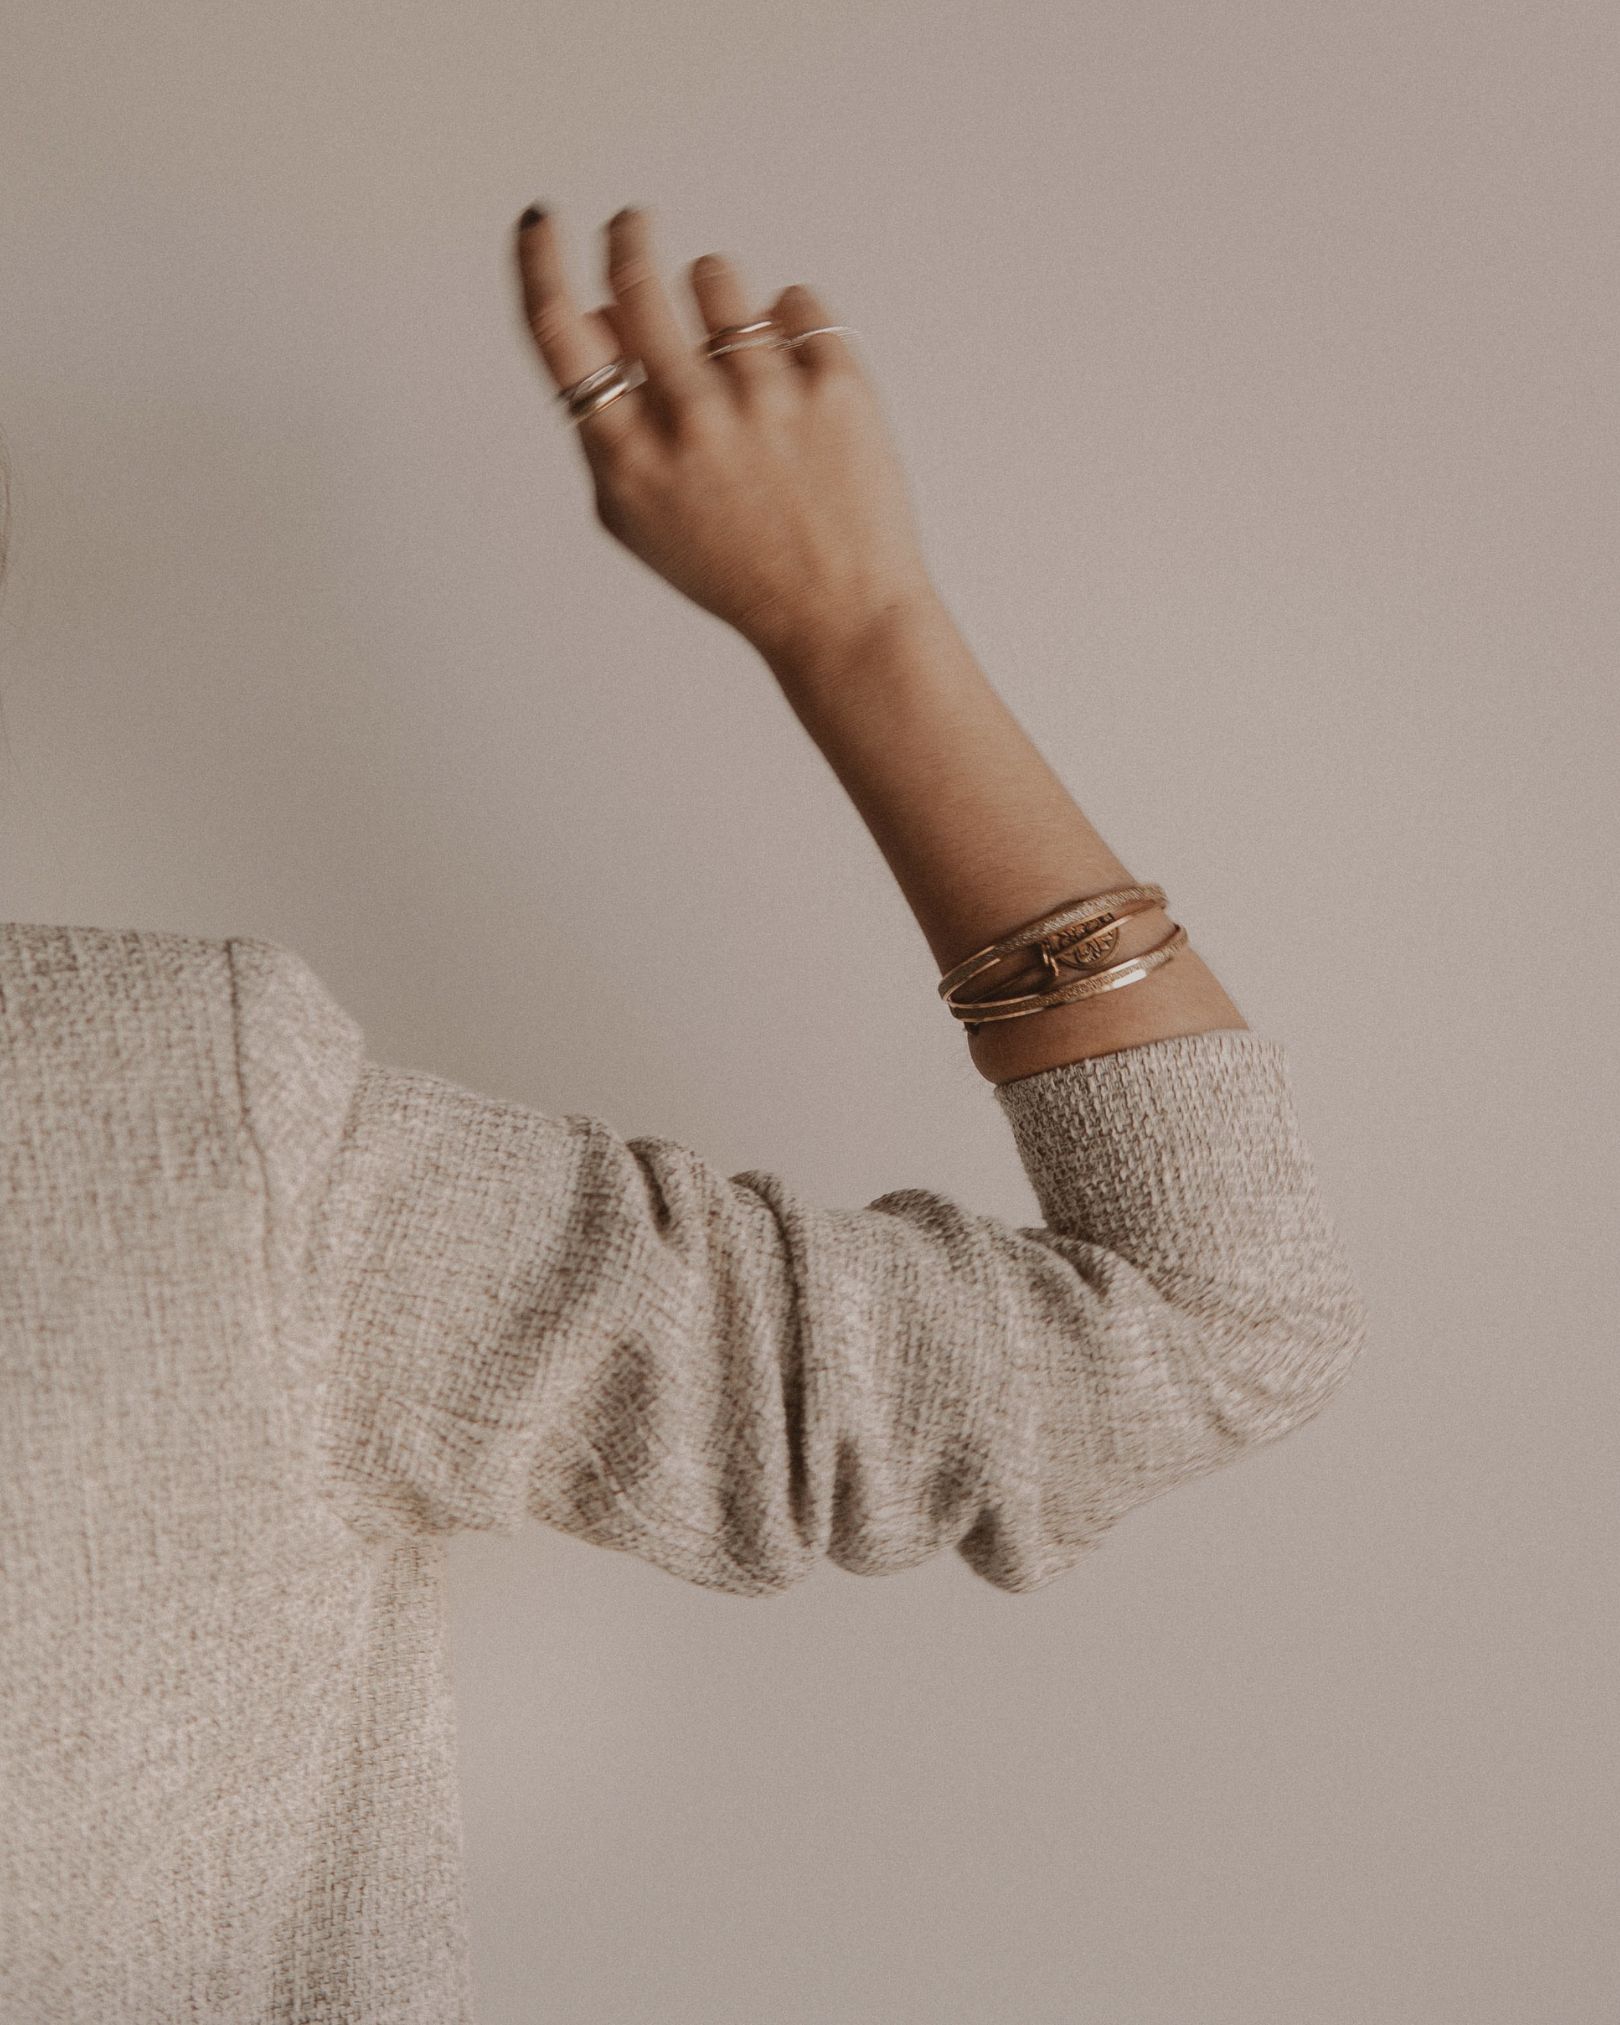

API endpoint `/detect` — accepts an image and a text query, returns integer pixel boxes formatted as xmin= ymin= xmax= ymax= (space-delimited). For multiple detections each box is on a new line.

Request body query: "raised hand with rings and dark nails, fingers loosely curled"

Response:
xmin=506 ymin=209 xmax=934 ymax=662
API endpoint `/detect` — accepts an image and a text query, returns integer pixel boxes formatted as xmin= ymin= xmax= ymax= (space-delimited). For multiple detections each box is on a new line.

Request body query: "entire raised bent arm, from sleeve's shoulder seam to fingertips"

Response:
xmin=211 ymin=205 xmax=1365 ymax=1596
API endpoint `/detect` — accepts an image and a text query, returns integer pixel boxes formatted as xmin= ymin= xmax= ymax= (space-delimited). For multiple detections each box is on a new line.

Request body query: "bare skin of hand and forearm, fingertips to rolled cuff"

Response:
xmin=518 ymin=211 xmax=1247 ymax=1083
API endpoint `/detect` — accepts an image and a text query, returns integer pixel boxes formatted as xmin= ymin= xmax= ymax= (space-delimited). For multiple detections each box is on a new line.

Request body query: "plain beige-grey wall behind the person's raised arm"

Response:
xmin=0 ymin=0 xmax=1620 ymax=2025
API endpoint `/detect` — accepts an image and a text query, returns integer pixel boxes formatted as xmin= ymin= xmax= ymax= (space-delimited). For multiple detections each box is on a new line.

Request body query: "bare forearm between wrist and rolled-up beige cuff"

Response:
xmin=770 ymin=599 xmax=1247 ymax=1083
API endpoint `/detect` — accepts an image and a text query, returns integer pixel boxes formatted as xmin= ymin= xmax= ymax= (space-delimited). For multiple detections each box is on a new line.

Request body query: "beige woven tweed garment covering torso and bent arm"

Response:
xmin=0 ymin=923 xmax=1367 ymax=2025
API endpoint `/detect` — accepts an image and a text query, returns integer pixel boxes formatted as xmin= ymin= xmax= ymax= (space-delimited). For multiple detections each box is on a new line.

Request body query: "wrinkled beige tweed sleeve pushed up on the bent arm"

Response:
xmin=233 ymin=942 xmax=1365 ymax=1596
